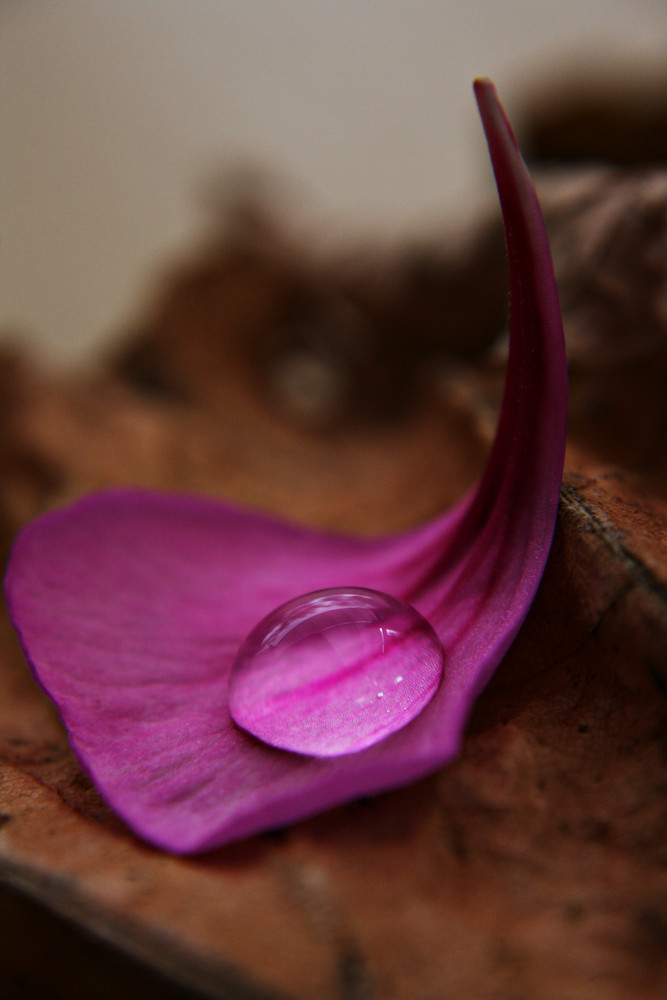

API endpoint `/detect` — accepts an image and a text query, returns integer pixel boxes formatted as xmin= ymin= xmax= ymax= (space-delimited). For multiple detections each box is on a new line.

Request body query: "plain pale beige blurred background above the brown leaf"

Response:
xmin=0 ymin=0 xmax=667 ymax=368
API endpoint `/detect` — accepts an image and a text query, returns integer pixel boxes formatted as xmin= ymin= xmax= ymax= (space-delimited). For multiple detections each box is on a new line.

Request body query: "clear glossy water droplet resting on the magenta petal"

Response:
xmin=229 ymin=587 xmax=444 ymax=757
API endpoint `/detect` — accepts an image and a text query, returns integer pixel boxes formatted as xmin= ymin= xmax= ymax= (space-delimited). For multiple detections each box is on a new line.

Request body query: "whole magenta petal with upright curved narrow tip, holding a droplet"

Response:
xmin=6 ymin=82 xmax=566 ymax=853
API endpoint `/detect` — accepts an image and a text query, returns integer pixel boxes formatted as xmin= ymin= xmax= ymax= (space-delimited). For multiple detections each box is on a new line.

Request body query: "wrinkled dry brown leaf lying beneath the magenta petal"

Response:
xmin=0 ymin=168 xmax=667 ymax=1000
